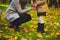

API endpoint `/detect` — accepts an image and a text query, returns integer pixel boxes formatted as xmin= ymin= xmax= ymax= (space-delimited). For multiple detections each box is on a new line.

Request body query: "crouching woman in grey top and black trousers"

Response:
xmin=5 ymin=0 xmax=33 ymax=30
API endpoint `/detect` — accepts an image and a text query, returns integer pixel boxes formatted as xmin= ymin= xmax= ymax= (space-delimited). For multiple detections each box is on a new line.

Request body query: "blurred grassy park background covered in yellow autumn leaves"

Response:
xmin=0 ymin=0 xmax=60 ymax=40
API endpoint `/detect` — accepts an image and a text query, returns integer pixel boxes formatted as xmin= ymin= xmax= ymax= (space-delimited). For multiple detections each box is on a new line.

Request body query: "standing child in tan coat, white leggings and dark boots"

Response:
xmin=31 ymin=0 xmax=48 ymax=33
